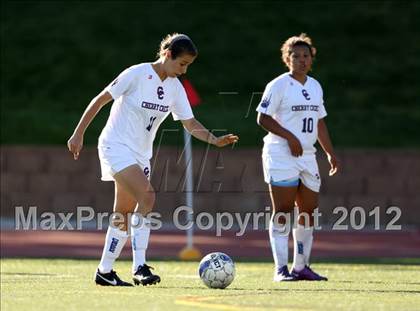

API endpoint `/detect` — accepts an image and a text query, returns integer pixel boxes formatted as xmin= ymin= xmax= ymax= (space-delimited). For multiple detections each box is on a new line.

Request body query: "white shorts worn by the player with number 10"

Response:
xmin=262 ymin=154 xmax=321 ymax=192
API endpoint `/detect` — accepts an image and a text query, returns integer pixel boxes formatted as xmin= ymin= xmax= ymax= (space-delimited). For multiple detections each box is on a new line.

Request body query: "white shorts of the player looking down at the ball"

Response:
xmin=98 ymin=144 xmax=150 ymax=181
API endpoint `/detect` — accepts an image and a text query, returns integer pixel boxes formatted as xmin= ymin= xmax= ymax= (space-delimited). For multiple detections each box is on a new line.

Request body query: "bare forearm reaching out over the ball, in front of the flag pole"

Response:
xmin=181 ymin=118 xmax=239 ymax=147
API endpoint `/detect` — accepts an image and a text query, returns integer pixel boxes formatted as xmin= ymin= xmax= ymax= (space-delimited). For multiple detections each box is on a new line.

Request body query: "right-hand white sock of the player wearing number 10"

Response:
xmin=293 ymin=224 xmax=314 ymax=271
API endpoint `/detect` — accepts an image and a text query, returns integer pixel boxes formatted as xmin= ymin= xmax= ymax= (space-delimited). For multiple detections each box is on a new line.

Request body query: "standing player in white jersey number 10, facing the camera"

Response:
xmin=257 ymin=34 xmax=338 ymax=282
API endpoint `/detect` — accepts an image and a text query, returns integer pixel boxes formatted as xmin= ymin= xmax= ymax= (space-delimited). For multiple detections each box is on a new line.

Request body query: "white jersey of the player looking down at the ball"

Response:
xmin=99 ymin=63 xmax=194 ymax=159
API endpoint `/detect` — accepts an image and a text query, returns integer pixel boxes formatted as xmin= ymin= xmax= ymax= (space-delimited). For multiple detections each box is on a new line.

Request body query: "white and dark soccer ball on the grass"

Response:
xmin=198 ymin=252 xmax=235 ymax=288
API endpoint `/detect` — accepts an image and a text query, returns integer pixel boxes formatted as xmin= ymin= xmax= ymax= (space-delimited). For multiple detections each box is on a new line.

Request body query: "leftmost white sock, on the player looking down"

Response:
xmin=98 ymin=226 xmax=128 ymax=273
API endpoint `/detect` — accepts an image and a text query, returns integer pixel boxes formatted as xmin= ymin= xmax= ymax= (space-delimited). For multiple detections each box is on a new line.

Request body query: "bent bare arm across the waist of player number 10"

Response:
xmin=257 ymin=113 xmax=303 ymax=157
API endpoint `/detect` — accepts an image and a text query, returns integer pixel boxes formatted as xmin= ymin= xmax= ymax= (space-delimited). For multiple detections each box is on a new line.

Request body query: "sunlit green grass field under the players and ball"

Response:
xmin=1 ymin=259 xmax=420 ymax=311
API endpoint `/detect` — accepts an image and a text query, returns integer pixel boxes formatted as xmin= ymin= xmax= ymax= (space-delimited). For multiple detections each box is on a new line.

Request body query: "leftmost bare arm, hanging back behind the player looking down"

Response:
xmin=67 ymin=91 xmax=112 ymax=160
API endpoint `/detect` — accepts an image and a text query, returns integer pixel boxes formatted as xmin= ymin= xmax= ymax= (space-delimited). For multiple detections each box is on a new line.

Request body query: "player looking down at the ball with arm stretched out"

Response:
xmin=67 ymin=34 xmax=238 ymax=286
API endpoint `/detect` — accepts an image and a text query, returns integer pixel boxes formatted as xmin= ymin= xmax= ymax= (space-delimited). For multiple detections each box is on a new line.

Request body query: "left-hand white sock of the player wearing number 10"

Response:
xmin=268 ymin=217 xmax=289 ymax=271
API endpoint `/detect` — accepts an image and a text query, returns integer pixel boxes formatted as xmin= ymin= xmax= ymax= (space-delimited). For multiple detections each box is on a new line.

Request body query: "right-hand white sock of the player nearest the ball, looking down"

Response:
xmin=131 ymin=214 xmax=150 ymax=273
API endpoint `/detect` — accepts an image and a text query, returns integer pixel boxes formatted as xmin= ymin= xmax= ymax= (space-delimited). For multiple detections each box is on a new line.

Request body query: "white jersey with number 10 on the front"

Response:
xmin=256 ymin=72 xmax=327 ymax=155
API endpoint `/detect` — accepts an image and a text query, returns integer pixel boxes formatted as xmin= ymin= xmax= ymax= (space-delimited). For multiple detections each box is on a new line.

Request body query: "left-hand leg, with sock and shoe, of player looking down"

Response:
xmin=95 ymin=181 xmax=137 ymax=286
